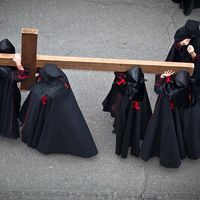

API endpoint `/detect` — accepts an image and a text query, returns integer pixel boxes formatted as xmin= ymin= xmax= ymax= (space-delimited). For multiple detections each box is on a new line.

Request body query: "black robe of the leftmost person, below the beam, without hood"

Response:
xmin=0 ymin=67 xmax=21 ymax=138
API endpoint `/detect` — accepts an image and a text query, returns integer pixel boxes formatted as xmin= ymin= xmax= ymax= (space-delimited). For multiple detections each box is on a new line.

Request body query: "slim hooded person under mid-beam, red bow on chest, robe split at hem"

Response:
xmin=114 ymin=67 xmax=152 ymax=158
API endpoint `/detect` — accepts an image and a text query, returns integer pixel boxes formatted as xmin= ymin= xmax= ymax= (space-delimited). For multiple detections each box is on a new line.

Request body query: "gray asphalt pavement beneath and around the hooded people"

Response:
xmin=0 ymin=0 xmax=200 ymax=200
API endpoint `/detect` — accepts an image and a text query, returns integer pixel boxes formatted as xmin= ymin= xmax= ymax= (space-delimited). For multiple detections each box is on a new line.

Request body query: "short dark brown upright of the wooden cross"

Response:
xmin=21 ymin=28 xmax=38 ymax=90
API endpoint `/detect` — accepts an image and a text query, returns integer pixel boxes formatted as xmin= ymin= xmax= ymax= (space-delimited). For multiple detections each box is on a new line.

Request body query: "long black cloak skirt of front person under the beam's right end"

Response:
xmin=141 ymin=97 xmax=184 ymax=168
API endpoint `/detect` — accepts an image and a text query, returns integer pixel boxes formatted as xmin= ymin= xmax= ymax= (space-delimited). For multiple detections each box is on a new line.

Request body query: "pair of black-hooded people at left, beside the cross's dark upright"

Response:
xmin=0 ymin=39 xmax=98 ymax=157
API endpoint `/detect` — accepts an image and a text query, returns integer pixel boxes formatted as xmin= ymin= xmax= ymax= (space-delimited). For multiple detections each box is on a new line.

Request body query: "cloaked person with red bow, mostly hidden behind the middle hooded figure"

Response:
xmin=102 ymin=72 xmax=126 ymax=117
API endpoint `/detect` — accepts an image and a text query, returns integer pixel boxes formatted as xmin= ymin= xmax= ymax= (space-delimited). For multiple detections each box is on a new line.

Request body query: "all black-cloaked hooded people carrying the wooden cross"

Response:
xmin=0 ymin=20 xmax=200 ymax=167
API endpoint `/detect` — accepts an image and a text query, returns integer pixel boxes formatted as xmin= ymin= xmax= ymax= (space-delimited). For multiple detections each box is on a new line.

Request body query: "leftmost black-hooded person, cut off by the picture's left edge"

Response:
xmin=0 ymin=39 xmax=28 ymax=138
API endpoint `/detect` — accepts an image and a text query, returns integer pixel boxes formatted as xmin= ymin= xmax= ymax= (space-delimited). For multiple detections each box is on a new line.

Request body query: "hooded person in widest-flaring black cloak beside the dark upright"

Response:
xmin=19 ymin=64 xmax=98 ymax=157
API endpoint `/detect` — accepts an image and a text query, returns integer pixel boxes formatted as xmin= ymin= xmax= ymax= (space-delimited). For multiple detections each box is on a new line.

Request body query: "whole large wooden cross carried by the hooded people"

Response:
xmin=0 ymin=28 xmax=194 ymax=89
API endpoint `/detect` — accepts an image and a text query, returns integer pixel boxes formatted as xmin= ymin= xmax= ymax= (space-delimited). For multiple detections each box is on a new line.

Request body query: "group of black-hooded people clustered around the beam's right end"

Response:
xmin=102 ymin=20 xmax=200 ymax=168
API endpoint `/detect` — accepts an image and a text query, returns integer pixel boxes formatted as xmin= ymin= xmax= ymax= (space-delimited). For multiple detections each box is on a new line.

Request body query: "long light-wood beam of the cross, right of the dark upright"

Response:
xmin=37 ymin=55 xmax=194 ymax=73
